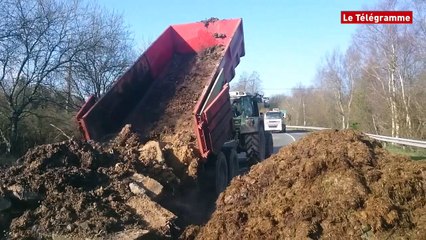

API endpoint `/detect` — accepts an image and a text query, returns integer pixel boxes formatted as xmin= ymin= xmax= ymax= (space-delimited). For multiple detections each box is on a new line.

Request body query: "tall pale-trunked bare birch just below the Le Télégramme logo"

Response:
xmin=355 ymin=1 xmax=415 ymax=137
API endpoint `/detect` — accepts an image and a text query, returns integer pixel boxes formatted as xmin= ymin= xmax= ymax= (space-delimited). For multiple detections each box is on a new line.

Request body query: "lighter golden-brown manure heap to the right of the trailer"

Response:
xmin=196 ymin=130 xmax=426 ymax=239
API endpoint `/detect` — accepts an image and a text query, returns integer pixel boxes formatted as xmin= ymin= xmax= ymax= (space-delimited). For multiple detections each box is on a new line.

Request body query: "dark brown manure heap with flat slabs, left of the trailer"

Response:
xmin=0 ymin=126 xmax=180 ymax=239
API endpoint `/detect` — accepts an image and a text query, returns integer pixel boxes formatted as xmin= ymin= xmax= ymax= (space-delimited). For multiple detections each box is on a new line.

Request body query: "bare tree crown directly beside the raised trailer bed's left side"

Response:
xmin=70 ymin=6 xmax=135 ymax=97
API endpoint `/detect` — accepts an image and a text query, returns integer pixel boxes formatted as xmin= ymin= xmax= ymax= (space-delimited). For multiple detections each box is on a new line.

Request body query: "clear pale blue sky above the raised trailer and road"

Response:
xmin=99 ymin=0 xmax=377 ymax=96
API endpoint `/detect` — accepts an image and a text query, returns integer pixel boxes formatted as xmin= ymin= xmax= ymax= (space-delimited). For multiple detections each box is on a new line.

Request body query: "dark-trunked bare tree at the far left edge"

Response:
xmin=0 ymin=0 xmax=91 ymax=151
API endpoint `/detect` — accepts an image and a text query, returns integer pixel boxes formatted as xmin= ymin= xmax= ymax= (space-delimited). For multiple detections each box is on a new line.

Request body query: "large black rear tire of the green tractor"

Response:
xmin=245 ymin=128 xmax=265 ymax=163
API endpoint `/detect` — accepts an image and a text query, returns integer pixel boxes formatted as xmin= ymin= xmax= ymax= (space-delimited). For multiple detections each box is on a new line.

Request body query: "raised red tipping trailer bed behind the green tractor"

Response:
xmin=76 ymin=19 xmax=244 ymax=158
